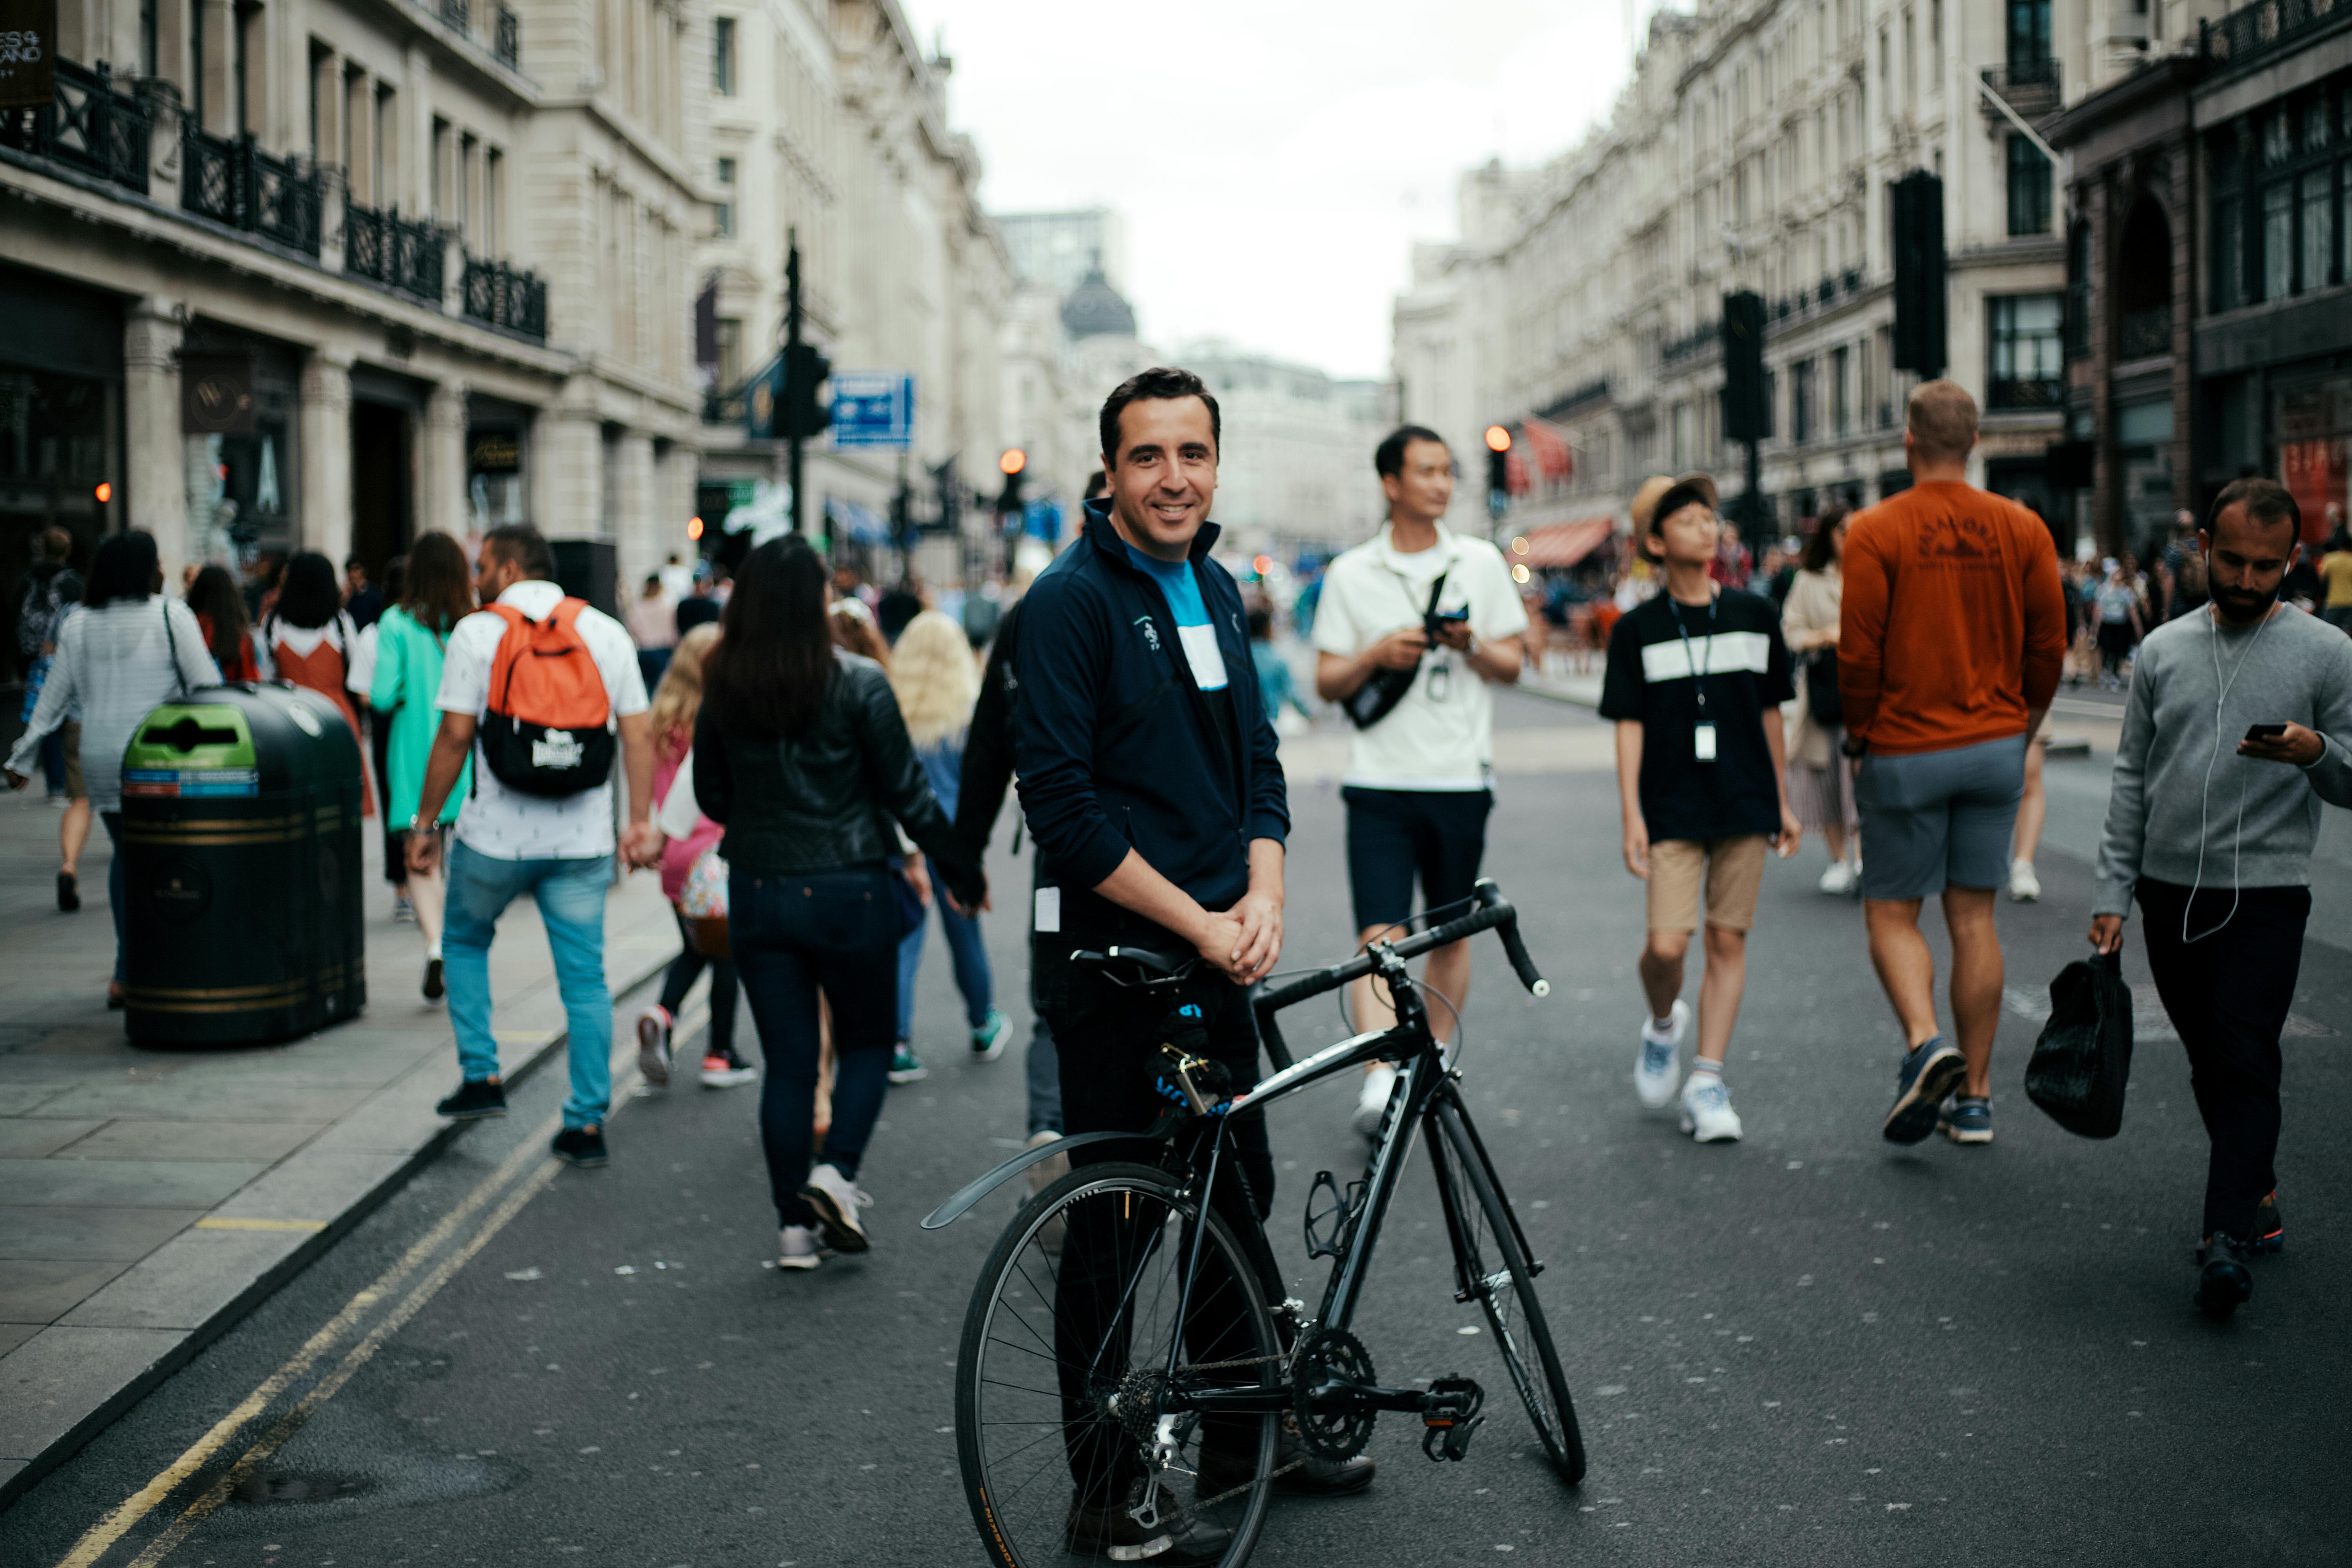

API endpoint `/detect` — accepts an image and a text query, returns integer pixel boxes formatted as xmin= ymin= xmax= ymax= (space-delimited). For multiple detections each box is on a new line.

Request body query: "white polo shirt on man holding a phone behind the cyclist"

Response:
xmin=1315 ymin=526 xmax=1527 ymax=790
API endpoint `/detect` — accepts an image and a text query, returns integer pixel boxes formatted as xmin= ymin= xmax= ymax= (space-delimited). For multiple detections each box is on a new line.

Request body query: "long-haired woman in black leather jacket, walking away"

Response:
xmin=694 ymin=538 xmax=988 ymax=1267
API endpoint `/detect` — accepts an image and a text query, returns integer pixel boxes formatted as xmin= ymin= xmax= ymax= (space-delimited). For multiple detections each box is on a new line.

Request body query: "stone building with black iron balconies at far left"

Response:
xmin=0 ymin=0 xmax=710 ymax=611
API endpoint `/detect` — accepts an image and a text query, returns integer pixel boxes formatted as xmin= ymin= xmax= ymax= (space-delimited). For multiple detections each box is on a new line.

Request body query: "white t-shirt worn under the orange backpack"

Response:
xmin=433 ymin=583 xmax=647 ymax=860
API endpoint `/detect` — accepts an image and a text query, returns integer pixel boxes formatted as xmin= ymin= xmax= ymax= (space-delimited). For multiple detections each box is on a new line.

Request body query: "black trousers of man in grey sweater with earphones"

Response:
xmin=2138 ymin=882 xmax=2312 ymax=1237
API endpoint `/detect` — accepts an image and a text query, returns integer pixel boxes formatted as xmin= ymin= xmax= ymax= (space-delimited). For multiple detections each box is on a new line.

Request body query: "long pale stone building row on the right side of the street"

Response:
xmin=1393 ymin=0 xmax=2195 ymax=557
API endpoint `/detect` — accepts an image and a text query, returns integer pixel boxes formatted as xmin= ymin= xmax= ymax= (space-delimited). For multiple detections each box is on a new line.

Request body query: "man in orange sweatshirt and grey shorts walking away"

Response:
xmin=1837 ymin=381 xmax=2065 ymax=1142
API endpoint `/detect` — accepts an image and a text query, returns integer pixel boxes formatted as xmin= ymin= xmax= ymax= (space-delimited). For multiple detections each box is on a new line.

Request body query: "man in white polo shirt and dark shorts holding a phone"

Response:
xmin=1315 ymin=426 xmax=1527 ymax=1138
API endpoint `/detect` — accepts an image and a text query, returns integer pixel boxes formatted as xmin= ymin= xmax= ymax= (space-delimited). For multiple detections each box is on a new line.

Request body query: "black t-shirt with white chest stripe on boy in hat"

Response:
xmin=1602 ymin=588 xmax=1795 ymax=842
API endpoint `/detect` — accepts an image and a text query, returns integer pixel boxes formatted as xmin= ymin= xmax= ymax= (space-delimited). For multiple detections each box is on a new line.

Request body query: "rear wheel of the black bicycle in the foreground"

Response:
xmin=955 ymin=1164 xmax=1284 ymax=1568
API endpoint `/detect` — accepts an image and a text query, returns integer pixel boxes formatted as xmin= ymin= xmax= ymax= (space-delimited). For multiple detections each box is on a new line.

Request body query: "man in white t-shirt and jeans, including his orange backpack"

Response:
xmin=409 ymin=524 xmax=656 ymax=1166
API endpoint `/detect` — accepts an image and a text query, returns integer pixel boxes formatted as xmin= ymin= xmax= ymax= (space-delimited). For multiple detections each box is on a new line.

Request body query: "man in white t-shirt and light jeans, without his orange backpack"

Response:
xmin=409 ymin=524 xmax=654 ymax=1166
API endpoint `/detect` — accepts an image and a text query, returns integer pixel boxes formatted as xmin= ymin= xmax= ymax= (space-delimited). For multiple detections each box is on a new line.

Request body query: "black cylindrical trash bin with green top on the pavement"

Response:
xmin=115 ymin=684 xmax=367 ymax=1046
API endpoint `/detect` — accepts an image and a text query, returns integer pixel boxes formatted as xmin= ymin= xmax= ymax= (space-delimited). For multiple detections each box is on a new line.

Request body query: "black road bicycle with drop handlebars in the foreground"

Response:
xmin=922 ymin=882 xmax=1585 ymax=1568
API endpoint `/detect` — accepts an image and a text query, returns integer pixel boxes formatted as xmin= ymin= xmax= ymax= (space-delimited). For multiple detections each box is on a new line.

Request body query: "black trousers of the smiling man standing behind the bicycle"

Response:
xmin=1035 ymin=954 xmax=1282 ymax=1502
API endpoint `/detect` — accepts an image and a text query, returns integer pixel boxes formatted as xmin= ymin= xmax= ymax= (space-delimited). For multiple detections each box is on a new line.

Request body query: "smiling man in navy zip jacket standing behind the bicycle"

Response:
xmin=1014 ymin=369 xmax=1374 ymax=1563
